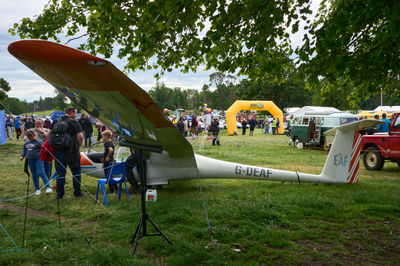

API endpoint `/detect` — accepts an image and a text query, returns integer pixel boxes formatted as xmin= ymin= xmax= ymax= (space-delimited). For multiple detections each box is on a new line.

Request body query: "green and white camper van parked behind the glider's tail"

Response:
xmin=290 ymin=112 xmax=358 ymax=149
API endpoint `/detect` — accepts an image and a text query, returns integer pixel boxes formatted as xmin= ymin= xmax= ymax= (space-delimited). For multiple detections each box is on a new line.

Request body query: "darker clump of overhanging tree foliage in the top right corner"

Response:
xmin=296 ymin=0 xmax=400 ymax=99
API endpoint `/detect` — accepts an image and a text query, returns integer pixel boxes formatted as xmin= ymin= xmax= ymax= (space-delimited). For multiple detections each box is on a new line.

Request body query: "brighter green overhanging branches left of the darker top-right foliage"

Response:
xmin=10 ymin=0 xmax=311 ymax=80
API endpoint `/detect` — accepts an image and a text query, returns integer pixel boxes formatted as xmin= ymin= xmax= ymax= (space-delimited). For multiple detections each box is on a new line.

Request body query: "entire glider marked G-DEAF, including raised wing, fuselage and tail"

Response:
xmin=8 ymin=40 xmax=377 ymax=185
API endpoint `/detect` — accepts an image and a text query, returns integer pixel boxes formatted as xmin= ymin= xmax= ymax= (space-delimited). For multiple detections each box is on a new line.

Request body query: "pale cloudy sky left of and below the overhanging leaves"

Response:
xmin=0 ymin=0 xmax=319 ymax=102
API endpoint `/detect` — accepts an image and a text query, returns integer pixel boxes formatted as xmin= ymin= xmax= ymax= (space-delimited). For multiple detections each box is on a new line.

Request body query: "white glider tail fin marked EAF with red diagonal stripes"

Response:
xmin=321 ymin=121 xmax=369 ymax=184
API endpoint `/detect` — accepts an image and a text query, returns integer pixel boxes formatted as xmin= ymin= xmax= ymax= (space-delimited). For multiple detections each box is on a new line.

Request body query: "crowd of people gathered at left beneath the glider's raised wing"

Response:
xmin=5 ymin=106 xmax=115 ymax=199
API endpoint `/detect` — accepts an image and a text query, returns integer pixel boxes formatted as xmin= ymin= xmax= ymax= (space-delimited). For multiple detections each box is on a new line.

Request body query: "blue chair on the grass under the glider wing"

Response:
xmin=96 ymin=162 xmax=131 ymax=206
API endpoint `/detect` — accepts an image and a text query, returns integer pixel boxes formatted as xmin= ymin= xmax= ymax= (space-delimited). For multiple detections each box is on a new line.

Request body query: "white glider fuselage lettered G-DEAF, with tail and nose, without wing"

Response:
xmin=81 ymin=120 xmax=379 ymax=185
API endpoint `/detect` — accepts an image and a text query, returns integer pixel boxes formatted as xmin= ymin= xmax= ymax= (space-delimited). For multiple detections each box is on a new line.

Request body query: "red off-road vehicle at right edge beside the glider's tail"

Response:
xmin=360 ymin=113 xmax=400 ymax=170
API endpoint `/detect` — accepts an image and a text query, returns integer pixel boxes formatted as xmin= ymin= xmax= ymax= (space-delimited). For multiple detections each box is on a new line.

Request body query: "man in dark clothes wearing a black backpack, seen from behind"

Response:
xmin=49 ymin=106 xmax=83 ymax=199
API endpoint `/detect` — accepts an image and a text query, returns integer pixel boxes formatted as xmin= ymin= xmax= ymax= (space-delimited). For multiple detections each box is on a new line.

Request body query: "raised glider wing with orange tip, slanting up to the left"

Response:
xmin=8 ymin=40 xmax=196 ymax=168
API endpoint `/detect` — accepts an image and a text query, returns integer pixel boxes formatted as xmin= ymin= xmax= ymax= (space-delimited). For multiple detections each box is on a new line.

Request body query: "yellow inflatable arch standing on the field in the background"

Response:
xmin=226 ymin=101 xmax=284 ymax=135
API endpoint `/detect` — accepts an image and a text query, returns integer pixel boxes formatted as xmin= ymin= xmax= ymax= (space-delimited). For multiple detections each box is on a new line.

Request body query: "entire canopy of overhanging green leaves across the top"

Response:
xmin=10 ymin=0 xmax=400 ymax=98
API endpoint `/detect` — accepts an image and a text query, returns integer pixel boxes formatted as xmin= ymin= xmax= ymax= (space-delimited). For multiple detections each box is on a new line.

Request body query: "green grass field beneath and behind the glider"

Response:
xmin=0 ymin=130 xmax=400 ymax=265
